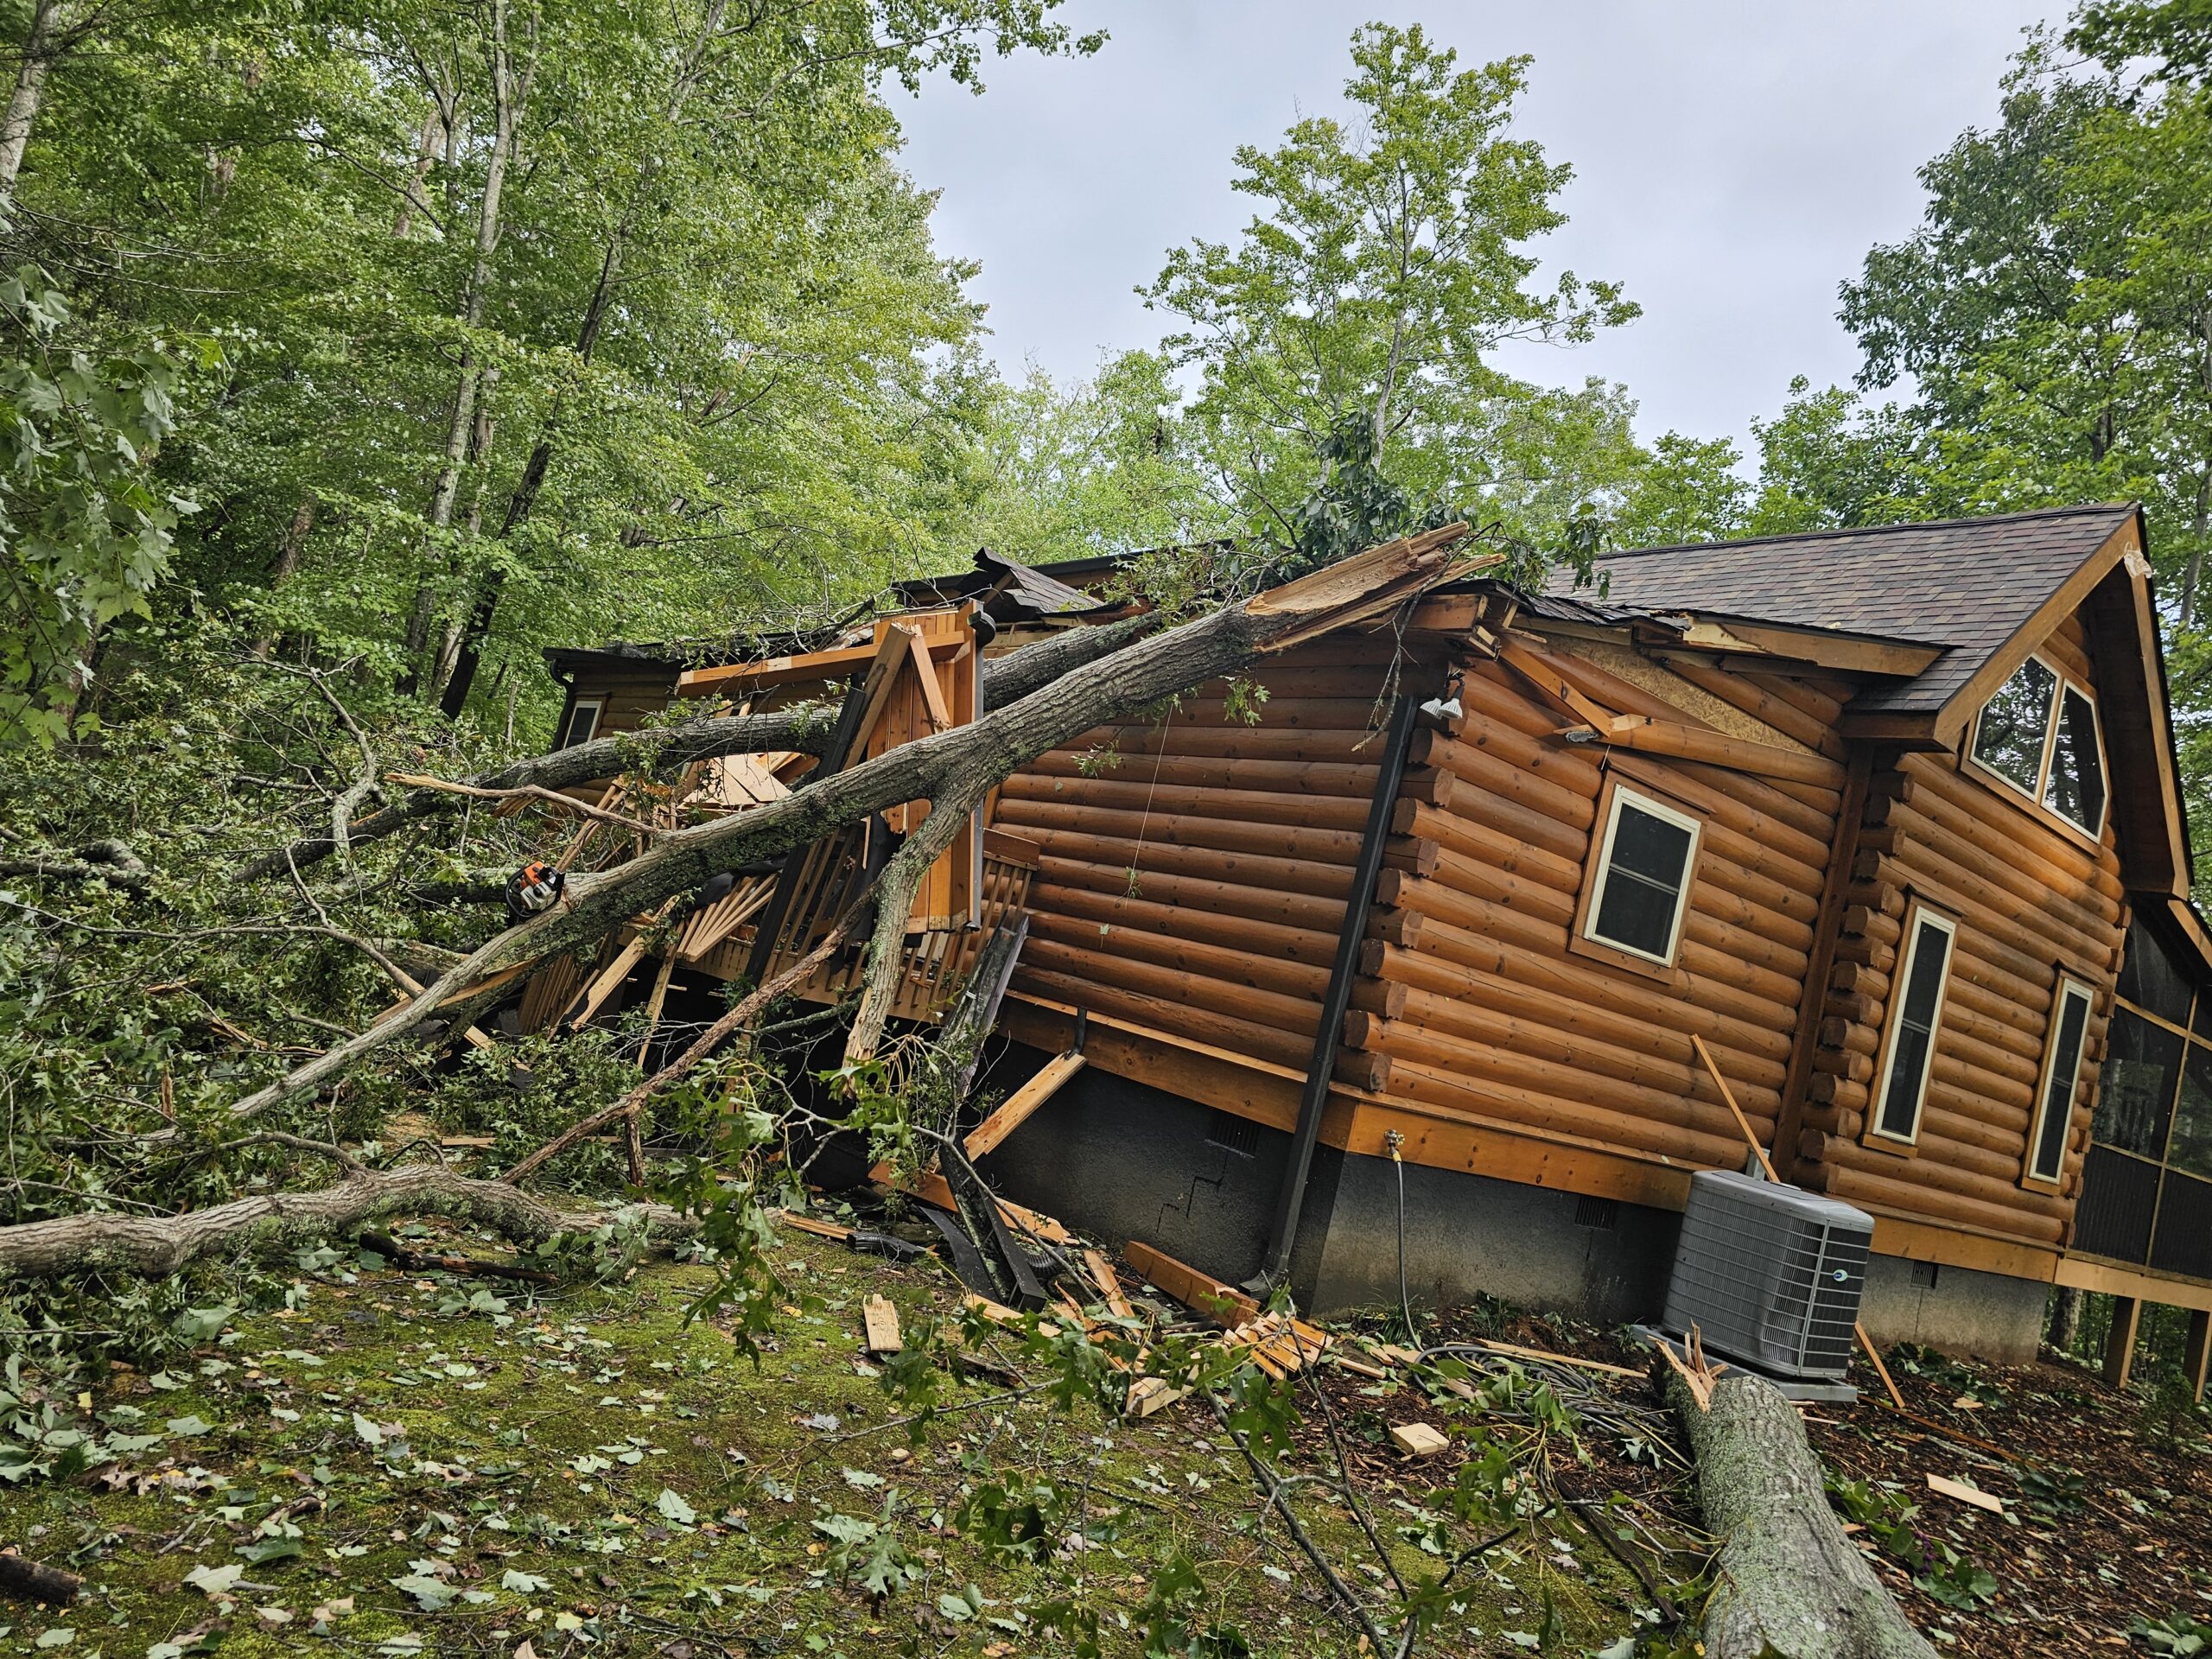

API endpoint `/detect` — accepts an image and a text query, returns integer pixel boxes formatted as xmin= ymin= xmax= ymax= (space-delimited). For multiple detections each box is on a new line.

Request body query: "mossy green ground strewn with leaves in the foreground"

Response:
xmin=0 ymin=1234 xmax=1663 ymax=1659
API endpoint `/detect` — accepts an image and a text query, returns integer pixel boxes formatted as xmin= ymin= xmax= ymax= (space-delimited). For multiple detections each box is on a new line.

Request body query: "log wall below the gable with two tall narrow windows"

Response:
xmin=1787 ymin=620 xmax=2128 ymax=1245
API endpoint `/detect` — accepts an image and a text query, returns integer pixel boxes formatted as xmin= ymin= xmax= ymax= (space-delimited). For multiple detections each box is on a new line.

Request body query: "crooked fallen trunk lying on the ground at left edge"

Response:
xmin=0 ymin=1164 xmax=695 ymax=1281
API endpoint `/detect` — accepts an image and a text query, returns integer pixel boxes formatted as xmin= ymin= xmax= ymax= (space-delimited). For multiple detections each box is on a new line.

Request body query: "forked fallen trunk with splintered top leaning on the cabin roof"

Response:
xmin=232 ymin=524 xmax=1502 ymax=1117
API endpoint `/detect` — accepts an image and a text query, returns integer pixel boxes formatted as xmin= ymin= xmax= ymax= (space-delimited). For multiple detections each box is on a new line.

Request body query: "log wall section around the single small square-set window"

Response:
xmin=1344 ymin=657 xmax=1838 ymax=1168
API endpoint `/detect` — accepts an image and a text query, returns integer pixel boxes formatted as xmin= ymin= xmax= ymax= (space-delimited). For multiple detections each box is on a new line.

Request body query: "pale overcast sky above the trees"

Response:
xmin=898 ymin=0 xmax=2066 ymax=462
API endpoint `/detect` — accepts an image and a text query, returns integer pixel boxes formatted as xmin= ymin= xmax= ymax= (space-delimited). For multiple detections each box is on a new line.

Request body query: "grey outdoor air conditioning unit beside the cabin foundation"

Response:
xmin=1666 ymin=1170 xmax=1873 ymax=1380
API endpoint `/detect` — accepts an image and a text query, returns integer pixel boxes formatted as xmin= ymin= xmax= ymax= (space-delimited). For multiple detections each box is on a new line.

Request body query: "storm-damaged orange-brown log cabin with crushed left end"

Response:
xmin=522 ymin=505 xmax=2212 ymax=1387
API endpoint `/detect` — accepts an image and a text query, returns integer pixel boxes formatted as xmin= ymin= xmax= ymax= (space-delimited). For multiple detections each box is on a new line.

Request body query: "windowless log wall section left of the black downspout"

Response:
xmin=993 ymin=639 xmax=1438 ymax=1086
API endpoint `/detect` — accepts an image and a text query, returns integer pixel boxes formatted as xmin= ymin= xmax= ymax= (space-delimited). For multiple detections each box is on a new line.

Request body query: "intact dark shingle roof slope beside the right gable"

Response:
xmin=1546 ymin=505 xmax=2134 ymax=712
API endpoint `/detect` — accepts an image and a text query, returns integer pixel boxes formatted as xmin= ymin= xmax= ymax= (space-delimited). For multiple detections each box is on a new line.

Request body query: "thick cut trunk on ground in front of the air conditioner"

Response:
xmin=1668 ymin=1371 xmax=1936 ymax=1659
